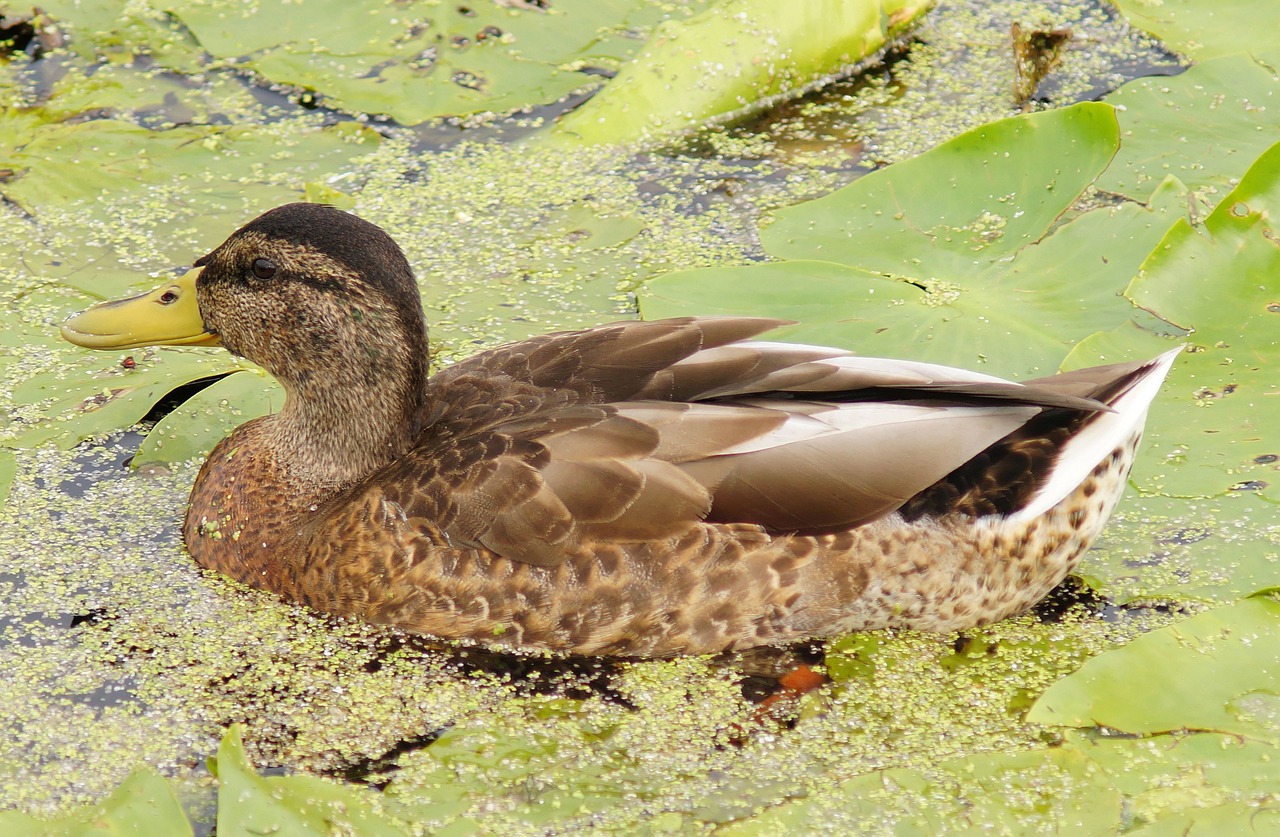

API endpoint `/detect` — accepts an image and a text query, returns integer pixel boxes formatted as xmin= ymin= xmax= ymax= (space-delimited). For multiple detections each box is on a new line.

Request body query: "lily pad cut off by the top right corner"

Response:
xmin=1115 ymin=0 xmax=1280 ymax=60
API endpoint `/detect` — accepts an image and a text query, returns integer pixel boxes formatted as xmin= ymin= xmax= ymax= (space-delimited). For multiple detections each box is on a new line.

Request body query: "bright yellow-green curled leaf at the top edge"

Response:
xmin=554 ymin=0 xmax=933 ymax=143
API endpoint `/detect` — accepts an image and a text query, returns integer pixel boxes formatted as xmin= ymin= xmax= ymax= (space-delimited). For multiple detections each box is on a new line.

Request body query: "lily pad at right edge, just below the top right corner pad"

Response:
xmin=1097 ymin=52 xmax=1280 ymax=206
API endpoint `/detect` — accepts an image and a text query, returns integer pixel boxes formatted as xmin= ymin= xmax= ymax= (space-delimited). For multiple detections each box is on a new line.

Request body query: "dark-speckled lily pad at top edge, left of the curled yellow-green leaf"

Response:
xmin=40 ymin=0 xmax=705 ymax=124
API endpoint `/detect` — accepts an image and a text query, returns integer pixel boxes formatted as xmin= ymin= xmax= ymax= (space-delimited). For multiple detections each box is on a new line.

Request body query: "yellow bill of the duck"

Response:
xmin=63 ymin=267 xmax=221 ymax=349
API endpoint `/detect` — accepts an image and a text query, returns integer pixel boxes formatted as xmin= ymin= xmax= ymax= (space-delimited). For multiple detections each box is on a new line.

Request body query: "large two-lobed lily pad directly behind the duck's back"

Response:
xmin=641 ymin=104 xmax=1162 ymax=375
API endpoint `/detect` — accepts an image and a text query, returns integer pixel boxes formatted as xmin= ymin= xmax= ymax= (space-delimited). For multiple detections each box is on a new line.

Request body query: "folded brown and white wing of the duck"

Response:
xmin=394 ymin=317 xmax=1106 ymax=566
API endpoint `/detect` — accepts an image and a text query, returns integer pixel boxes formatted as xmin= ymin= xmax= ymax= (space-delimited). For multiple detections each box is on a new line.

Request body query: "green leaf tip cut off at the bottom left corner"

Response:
xmin=0 ymin=768 xmax=192 ymax=837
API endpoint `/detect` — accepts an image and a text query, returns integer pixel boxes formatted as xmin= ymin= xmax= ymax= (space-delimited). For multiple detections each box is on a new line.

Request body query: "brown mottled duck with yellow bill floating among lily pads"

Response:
xmin=61 ymin=203 xmax=1180 ymax=658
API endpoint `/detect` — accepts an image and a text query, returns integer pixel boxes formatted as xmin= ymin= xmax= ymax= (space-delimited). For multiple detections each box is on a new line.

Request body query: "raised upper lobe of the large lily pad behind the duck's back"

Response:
xmin=760 ymin=102 xmax=1120 ymax=268
